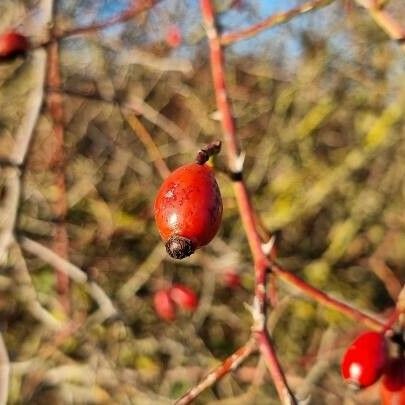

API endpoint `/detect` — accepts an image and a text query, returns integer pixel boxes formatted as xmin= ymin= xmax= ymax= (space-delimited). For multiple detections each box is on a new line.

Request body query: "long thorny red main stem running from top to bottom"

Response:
xmin=200 ymin=0 xmax=295 ymax=404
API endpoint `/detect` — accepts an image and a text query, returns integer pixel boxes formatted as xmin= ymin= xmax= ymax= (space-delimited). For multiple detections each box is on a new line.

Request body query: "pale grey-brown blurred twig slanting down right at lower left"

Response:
xmin=20 ymin=237 xmax=118 ymax=319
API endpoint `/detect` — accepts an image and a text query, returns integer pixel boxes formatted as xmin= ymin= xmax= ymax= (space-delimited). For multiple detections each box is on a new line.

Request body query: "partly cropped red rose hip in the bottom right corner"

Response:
xmin=380 ymin=358 xmax=405 ymax=405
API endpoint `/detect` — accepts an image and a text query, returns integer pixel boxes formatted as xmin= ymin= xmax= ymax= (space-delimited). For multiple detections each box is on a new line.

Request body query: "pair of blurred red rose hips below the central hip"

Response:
xmin=153 ymin=284 xmax=198 ymax=321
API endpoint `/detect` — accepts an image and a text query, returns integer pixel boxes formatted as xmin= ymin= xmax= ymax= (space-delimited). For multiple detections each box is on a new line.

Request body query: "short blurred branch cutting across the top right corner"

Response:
xmin=356 ymin=0 xmax=405 ymax=51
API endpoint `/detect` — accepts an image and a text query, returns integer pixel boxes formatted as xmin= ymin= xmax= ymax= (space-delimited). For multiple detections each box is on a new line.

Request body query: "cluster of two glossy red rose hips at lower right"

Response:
xmin=341 ymin=332 xmax=405 ymax=405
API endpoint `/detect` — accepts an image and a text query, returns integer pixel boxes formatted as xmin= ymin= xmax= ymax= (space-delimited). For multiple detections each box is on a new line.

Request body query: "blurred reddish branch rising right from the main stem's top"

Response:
xmin=220 ymin=0 xmax=334 ymax=45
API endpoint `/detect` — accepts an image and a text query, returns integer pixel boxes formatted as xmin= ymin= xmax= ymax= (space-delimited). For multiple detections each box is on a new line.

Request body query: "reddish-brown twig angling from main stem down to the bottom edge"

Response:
xmin=175 ymin=339 xmax=256 ymax=405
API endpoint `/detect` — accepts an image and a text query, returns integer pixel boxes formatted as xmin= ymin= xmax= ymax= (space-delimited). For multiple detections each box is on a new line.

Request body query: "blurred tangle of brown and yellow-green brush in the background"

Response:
xmin=0 ymin=0 xmax=405 ymax=405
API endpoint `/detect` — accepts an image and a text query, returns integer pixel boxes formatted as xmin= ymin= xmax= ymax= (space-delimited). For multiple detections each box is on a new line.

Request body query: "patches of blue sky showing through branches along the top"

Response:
xmin=68 ymin=0 xmax=334 ymax=60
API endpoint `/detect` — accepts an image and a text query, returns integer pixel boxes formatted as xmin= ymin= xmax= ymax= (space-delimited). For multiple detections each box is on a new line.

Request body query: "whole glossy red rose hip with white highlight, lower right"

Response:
xmin=341 ymin=332 xmax=388 ymax=388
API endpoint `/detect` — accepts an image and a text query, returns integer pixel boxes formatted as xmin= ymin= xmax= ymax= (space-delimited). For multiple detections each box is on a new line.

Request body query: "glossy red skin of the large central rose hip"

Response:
xmin=154 ymin=163 xmax=222 ymax=248
